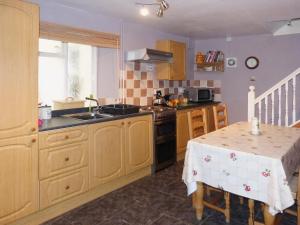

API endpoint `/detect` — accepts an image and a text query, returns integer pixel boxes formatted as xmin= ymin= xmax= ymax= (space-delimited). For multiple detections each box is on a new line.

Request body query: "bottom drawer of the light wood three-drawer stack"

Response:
xmin=40 ymin=167 xmax=88 ymax=209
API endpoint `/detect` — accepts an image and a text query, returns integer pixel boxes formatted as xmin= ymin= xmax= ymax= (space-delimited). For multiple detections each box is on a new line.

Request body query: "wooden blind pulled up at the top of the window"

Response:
xmin=40 ymin=22 xmax=120 ymax=48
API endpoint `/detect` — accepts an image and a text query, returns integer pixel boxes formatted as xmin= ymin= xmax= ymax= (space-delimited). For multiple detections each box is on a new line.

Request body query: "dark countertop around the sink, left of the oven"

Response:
xmin=39 ymin=112 xmax=152 ymax=131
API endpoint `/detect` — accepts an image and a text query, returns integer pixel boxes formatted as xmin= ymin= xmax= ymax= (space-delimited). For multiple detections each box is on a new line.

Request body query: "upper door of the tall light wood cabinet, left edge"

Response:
xmin=0 ymin=0 xmax=39 ymax=139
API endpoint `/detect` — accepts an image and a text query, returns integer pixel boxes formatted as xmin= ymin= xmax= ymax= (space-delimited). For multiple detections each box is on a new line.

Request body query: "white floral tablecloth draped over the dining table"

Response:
xmin=182 ymin=122 xmax=300 ymax=215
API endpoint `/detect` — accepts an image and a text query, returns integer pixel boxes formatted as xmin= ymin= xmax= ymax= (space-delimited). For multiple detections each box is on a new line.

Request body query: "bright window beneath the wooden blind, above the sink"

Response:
xmin=39 ymin=39 xmax=98 ymax=105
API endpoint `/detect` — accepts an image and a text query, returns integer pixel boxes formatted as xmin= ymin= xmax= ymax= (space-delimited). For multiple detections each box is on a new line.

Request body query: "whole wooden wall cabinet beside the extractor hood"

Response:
xmin=156 ymin=40 xmax=186 ymax=80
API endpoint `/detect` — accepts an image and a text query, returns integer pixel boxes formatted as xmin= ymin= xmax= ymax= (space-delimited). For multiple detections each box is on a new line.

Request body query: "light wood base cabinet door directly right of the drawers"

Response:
xmin=89 ymin=120 xmax=125 ymax=187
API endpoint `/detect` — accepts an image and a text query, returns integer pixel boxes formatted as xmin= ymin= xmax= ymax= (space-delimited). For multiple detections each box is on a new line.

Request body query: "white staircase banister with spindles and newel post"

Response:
xmin=248 ymin=68 xmax=300 ymax=127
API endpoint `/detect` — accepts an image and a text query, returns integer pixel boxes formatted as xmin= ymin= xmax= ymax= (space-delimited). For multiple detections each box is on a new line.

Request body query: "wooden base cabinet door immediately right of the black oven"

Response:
xmin=176 ymin=110 xmax=190 ymax=154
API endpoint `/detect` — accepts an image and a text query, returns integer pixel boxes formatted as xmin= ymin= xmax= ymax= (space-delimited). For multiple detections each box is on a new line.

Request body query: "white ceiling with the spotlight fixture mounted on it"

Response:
xmin=33 ymin=0 xmax=300 ymax=39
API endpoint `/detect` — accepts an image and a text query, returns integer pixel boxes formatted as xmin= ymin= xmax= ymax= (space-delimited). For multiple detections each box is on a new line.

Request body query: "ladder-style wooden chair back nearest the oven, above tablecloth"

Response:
xmin=188 ymin=108 xmax=208 ymax=139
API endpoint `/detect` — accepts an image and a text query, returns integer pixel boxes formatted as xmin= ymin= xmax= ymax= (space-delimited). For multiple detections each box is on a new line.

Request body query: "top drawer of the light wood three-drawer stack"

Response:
xmin=39 ymin=126 xmax=88 ymax=149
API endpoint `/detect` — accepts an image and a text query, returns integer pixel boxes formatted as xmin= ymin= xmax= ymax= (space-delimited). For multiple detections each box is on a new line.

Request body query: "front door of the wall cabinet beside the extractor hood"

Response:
xmin=170 ymin=41 xmax=186 ymax=80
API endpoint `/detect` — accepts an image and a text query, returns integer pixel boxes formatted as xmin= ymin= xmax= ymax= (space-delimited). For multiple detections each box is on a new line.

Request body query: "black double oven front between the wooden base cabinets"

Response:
xmin=154 ymin=116 xmax=176 ymax=171
